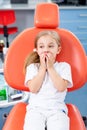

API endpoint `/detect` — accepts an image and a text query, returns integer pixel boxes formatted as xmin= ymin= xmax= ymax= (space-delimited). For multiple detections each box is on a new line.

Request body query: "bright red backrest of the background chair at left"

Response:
xmin=0 ymin=10 xmax=16 ymax=26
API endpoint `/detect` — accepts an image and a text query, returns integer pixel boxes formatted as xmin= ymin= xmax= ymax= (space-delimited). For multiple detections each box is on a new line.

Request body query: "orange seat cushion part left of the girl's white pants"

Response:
xmin=2 ymin=103 xmax=27 ymax=130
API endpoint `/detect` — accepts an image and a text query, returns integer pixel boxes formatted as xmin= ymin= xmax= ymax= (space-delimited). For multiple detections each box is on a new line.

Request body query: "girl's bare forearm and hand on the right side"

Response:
xmin=46 ymin=53 xmax=68 ymax=92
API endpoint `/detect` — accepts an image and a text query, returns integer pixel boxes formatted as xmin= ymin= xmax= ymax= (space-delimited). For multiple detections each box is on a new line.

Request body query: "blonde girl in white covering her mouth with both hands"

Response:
xmin=24 ymin=30 xmax=72 ymax=130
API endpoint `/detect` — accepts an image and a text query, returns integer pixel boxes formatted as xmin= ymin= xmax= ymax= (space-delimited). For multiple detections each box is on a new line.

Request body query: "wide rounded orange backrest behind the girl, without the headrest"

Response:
xmin=4 ymin=28 xmax=86 ymax=91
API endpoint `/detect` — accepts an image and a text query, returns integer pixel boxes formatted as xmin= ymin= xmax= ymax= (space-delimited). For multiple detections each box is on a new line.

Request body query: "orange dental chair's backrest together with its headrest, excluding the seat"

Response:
xmin=4 ymin=3 xmax=87 ymax=91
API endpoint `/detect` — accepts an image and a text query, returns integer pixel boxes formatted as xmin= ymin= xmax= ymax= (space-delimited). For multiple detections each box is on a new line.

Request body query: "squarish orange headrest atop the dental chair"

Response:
xmin=34 ymin=3 xmax=59 ymax=28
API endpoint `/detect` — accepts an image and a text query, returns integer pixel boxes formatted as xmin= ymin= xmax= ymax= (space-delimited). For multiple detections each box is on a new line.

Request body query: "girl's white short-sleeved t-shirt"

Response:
xmin=25 ymin=62 xmax=73 ymax=112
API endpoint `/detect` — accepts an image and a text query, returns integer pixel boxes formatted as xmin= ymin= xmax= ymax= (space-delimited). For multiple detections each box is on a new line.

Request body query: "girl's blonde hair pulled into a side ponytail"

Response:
xmin=24 ymin=30 xmax=60 ymax=72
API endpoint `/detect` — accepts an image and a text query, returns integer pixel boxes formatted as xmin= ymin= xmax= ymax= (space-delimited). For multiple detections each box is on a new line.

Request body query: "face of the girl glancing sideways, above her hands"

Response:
xmin=37 ymin=35 xmax=61 ymax=60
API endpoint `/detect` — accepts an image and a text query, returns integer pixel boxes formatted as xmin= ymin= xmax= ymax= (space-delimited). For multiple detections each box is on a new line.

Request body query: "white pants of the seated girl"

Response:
xmin=24 ymin=108 xmax=69 ymax=130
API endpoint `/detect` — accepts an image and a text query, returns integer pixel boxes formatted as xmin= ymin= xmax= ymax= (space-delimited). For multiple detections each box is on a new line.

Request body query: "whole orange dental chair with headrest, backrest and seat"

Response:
xmin=2 ymin=3 xmax=87 ymax=130
